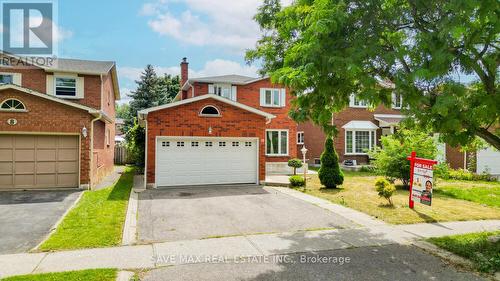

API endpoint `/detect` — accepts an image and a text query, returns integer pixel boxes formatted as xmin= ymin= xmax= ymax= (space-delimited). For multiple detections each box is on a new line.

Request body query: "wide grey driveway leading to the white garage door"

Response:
xmin=138 ymin=185 xmax=355 ymax=242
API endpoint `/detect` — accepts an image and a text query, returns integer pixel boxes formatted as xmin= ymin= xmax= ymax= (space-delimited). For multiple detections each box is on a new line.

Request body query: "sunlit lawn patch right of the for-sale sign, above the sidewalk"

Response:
xmin=435 ymin=180 xmax=500 ymax=207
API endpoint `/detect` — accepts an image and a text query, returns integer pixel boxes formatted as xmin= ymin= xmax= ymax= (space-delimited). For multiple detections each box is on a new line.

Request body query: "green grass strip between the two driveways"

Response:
xmin=39 ymin=167 xmax=134 ymax=251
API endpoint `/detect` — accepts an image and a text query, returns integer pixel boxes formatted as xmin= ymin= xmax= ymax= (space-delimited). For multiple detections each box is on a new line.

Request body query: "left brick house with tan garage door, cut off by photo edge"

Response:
xmin=0 ymin=53 xmax=120 ymax=190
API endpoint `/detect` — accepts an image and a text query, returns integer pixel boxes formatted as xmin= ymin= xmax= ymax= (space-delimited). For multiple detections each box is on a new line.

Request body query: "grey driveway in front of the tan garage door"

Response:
xmin=0 ymin=191 xmax=80 ymax=254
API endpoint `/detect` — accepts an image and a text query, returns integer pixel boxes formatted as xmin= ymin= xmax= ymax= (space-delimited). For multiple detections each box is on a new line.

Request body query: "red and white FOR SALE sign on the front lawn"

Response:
xmin=407 ymin=151 xmax=437 ymax=209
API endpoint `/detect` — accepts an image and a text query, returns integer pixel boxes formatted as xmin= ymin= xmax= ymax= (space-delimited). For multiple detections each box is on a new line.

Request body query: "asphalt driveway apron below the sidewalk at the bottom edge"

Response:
xmin=141 ymin=245 xmax=484 ymax=281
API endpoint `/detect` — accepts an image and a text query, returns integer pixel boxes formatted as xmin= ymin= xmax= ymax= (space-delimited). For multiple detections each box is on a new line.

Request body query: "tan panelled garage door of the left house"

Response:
xmin=0 ymin=135 xmax=79 ymax=190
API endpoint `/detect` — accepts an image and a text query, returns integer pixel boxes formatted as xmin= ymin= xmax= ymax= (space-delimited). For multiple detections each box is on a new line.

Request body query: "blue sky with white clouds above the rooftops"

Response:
xmin=54 ymin=0 xmax=274 ymax=103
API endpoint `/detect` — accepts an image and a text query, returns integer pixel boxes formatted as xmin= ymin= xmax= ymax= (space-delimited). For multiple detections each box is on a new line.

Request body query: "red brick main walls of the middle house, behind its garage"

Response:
xmin=189 ymin=79 xmax=297 ymax=162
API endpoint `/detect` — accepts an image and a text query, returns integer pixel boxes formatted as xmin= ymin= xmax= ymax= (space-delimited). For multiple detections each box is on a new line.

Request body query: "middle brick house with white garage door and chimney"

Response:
xmin=138 ymin=58 xmax=297 ymax=187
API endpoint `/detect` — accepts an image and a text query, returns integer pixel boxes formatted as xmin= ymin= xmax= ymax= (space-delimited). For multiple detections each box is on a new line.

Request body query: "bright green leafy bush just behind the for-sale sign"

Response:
xmin=368 ymin=129 xmax=437 ymax=187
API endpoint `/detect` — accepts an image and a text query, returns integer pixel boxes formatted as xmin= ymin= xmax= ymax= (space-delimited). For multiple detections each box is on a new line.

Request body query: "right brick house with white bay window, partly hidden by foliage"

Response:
xmin=297 ymin=94 xmax=467 ymax=169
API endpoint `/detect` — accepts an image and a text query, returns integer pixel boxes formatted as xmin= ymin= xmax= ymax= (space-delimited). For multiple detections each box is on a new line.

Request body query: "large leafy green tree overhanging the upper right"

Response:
xmin=246 ymin=0 xmax=500 ymax=149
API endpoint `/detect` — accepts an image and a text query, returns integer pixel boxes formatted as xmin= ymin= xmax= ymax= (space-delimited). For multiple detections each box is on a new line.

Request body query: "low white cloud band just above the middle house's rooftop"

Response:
xmin=118 ymin=59 xmax=258 ymax=81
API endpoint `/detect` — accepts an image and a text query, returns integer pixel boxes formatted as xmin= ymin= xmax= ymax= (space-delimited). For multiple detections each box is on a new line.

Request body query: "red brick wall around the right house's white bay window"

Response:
xmin=298 ymin=106 xmax=401 ymax=164
